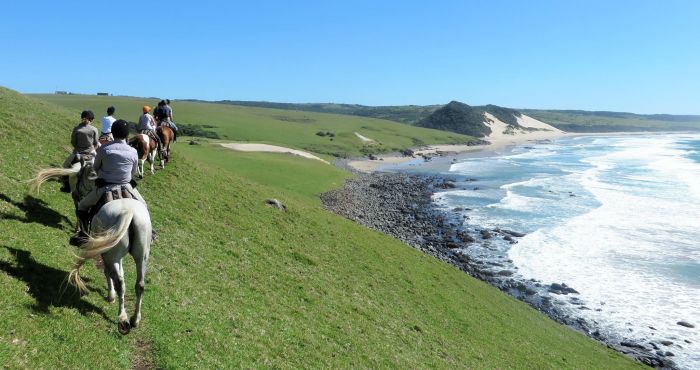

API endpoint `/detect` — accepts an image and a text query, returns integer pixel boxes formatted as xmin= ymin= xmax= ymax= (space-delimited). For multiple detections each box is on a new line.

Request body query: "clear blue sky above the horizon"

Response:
xmin=0 ymin=0 xmax=700 ymax=114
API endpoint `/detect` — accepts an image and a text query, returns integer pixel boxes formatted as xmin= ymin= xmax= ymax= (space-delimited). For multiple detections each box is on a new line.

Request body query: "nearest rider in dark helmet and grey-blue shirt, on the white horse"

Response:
xmin=76 ymin=119 xmax=155 ymax=240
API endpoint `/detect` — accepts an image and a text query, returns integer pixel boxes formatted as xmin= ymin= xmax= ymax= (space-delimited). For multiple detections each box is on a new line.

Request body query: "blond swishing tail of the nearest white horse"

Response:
xmin=68 ymin=209 xmax=134 ymax=293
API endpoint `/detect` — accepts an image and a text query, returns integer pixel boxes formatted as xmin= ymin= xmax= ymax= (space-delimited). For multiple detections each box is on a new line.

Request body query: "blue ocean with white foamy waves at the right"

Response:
xmin=423 ymin=133 xmax=700 ymax=369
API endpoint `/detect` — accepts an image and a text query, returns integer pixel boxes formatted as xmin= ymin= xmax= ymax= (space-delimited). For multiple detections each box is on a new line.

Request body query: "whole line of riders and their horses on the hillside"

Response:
xmin=32 ymin=100 xmax=177 ymax=334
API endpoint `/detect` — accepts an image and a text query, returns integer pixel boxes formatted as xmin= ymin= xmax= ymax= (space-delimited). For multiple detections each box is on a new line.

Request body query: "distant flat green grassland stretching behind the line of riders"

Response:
xmin=38 ymin=95 xmax=473 ymax=158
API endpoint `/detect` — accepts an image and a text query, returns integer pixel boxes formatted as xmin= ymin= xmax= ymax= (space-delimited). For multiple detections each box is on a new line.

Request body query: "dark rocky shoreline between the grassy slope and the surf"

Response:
xmin=321 ymin=172 xmax=676 ymax=369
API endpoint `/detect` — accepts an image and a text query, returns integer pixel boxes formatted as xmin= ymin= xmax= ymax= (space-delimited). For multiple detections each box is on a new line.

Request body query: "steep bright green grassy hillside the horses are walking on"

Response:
xmin=0 ymin=88 xmax=641 ymax=369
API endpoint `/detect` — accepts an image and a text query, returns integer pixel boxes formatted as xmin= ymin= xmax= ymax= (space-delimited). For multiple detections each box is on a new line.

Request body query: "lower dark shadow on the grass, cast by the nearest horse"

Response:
xmin=0 ymin=246 xmax=111 ymax=321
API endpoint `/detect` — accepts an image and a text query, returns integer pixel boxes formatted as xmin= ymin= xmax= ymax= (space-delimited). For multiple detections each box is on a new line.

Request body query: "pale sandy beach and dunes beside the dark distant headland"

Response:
xmin=348 ymin=113 xmax=571 ymax=173
